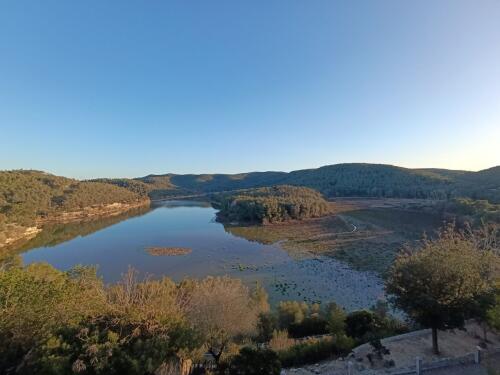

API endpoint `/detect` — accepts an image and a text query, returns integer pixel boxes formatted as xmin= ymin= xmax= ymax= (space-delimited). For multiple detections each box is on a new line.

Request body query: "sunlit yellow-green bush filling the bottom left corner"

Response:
xmin=0 ymin=264 xmax=105 ymax=372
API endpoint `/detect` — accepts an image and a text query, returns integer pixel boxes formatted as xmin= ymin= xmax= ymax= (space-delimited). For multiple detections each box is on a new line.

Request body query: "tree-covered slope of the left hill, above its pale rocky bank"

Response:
xmin=0 ymin=170 xmax=143 ymax=225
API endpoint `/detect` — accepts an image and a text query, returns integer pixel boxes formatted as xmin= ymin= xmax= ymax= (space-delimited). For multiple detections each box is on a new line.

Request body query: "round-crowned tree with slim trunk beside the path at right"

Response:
xmin=386 ymin=226 xmax=499 ymax=354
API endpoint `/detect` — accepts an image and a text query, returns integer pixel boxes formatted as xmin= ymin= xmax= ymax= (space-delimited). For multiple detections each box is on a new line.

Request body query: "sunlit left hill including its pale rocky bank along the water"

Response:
xmin=0 ymin=170 xmax=148 ymax=247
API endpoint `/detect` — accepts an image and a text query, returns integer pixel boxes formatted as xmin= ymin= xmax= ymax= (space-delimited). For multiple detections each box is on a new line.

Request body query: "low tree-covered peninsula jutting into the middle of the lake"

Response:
xmin=216 ymin=185 xmax=329 ymax=224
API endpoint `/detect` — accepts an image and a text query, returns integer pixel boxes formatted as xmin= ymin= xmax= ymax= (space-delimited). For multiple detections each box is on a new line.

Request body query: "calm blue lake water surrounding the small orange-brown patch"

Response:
xmin=22 ymin=201 xmax=383 ymax=309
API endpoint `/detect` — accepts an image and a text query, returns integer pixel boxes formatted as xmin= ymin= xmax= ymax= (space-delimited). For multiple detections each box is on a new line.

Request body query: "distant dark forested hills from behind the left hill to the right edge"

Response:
xmin=100 ymin=164 xmax=500 ymax=203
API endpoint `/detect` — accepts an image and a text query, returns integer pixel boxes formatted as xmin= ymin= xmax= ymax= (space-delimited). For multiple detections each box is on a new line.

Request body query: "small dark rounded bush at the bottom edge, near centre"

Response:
xmin=229 ymin=347 xmax=281 ymax=375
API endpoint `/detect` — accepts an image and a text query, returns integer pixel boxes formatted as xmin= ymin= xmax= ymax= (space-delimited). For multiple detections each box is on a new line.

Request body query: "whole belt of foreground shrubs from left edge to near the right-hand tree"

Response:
xmin=0 ymin=264 xmax=410 ymax=375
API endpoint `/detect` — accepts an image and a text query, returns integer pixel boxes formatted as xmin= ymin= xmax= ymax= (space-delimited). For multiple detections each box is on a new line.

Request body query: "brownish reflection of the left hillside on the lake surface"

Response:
xmin=16 ymin=207 xmax=151 ymax=253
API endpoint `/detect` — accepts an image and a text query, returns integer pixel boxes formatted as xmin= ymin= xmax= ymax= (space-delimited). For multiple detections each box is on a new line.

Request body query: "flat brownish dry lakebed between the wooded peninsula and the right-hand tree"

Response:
xmin=226 ymin=199 xmax=443 ymax=273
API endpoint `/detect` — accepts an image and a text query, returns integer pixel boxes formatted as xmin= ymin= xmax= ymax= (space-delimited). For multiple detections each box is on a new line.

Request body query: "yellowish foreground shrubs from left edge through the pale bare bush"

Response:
xmin=0 ymin=264 xmax=267 ymax=375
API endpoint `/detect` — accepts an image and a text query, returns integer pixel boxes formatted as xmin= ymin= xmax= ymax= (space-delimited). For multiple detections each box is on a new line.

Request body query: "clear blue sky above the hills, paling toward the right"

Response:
xmin=0 ymin=0 xmax=500 ymax=178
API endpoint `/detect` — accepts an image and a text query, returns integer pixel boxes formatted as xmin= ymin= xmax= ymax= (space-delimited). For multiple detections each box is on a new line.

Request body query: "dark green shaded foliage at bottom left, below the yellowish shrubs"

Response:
xmin=30 ymin=315 xmax=196 ymax=375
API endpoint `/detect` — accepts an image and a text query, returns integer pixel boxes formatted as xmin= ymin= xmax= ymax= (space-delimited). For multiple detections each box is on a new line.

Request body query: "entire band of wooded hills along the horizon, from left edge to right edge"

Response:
xmin=0 ymin=164 xmax=500 ymax=232
